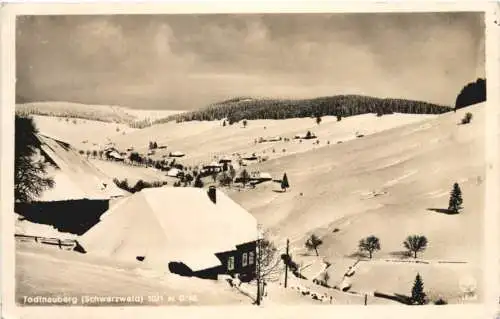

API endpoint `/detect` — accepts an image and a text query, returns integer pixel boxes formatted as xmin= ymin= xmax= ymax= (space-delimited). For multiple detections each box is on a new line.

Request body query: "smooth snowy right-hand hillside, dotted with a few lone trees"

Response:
xmin=228 ymin=104 xmax=485 ymax=303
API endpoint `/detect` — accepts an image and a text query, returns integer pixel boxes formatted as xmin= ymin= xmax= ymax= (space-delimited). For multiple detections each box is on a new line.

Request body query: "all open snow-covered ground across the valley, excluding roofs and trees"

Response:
xmin=17 ymin=105 xmax=485 ymax=304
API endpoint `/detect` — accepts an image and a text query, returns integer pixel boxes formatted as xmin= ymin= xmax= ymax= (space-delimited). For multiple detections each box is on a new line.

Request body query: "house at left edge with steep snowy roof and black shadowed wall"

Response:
xmin=14 ymin=134 xmax=128 ymax=234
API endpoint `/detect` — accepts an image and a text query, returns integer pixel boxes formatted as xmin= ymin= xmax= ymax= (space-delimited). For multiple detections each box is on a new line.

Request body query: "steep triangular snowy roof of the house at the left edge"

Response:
xmin=33 ymin=134 xmax=128 ymax=201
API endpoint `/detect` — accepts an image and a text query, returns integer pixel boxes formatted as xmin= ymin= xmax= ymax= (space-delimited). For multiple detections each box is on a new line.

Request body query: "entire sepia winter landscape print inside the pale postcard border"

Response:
xmin=13 ymin=12 xmax=487 ymax=307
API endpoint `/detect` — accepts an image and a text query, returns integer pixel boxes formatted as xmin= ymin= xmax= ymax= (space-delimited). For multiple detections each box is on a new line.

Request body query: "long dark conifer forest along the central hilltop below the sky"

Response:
xmin=159 ymin=95 xmax=453 ymax=125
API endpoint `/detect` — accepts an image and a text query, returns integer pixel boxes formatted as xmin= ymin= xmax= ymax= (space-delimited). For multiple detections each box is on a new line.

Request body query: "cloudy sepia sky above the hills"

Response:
xmin=16 ymin=13 xmax=485 ymax=110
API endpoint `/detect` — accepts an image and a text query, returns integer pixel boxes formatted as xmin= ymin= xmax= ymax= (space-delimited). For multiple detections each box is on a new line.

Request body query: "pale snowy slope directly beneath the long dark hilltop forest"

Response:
xmin=111 ymin=114 xmax=436 ymax=166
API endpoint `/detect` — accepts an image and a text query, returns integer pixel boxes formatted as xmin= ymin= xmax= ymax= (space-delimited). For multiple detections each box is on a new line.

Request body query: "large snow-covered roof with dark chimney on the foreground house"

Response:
xmin=80 ymin=187 xmax=257 ymax=271
